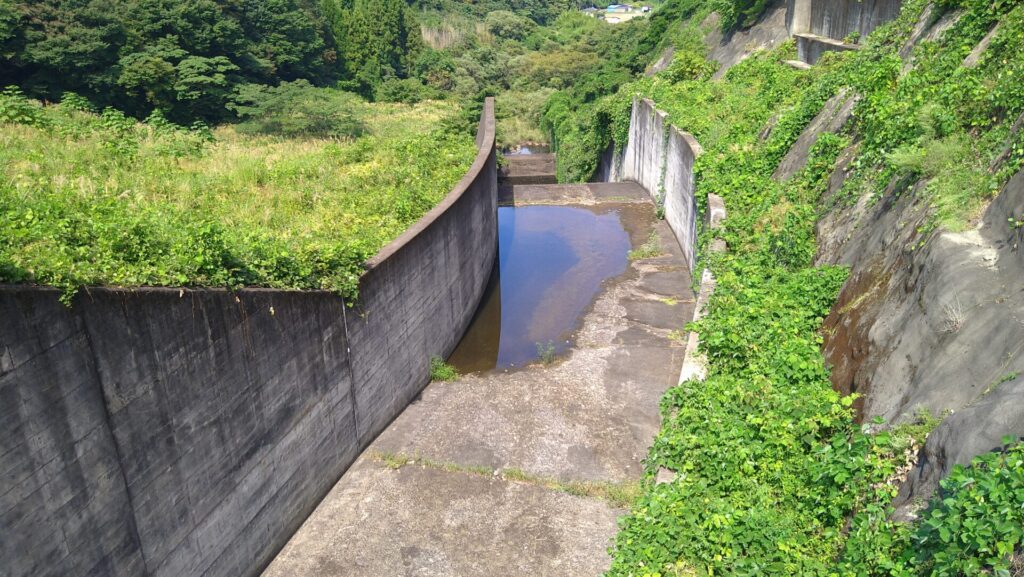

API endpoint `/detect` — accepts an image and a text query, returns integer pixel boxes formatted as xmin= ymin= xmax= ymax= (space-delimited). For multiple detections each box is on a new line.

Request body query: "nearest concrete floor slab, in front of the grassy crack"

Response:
xmin=264 ymin=459 xmax=621 ymax=577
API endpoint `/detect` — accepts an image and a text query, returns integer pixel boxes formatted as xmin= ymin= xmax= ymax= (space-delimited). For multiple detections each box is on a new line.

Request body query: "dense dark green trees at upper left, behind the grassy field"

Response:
xmin=0 ymin=0 xmax=438 ymax=124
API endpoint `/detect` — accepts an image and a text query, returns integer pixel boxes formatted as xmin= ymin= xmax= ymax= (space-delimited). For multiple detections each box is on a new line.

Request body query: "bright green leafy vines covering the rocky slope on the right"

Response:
xmin=528 ymin=0 xmax=1024 ymax=576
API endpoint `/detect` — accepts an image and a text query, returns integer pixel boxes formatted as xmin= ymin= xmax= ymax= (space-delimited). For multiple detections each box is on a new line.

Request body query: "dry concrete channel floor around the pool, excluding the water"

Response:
xmin=263 ymin=183 xmax=694 ymax=577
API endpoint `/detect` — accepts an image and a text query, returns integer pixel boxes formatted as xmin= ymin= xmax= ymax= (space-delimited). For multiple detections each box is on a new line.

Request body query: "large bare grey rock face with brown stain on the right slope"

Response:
xmin=818 ymin=140 xmax=1024 ymax=510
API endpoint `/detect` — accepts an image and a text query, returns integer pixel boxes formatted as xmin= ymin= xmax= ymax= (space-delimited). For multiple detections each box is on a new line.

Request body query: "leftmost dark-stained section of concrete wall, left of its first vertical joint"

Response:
xmin=0 ymin=288 xmax=144 ymax=577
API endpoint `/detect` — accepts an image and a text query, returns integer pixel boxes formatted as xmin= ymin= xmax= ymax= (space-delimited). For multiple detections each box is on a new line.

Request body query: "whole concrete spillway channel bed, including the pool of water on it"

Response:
xmin=264 ymin=147 xmax=694 ymax=577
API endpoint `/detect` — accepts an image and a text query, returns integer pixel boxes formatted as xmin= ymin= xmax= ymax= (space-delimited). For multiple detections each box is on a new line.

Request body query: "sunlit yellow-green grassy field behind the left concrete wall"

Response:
xmin=0 ymin=89 xmax=476 ymax=297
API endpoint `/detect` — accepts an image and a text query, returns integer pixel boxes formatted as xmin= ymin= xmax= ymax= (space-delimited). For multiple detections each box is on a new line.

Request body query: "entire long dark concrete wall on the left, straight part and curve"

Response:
xmin=0 ymin=99 xmax=498 ymax=577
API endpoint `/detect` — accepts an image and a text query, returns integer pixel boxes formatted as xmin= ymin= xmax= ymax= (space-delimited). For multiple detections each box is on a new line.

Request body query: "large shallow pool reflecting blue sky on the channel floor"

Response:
xmin=449 ymin=206 xmax=630 ymax=373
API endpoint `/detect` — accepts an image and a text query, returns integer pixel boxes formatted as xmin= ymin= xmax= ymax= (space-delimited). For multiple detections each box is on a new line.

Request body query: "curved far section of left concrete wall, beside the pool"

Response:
xmin=348 ymin=98 xmax=498 ymax=447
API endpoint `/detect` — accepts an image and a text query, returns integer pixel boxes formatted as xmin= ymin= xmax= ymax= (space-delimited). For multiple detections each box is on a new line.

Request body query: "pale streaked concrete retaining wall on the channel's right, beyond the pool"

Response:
xmin=596 ymin=98 xmax=703 ymax=270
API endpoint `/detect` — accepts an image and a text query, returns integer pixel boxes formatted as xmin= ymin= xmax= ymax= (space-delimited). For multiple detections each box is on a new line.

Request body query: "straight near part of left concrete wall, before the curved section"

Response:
xmin=0 ymin=287 xmax=358 ymax=576
